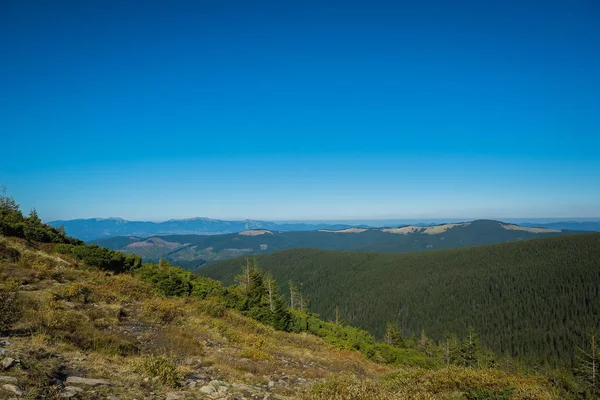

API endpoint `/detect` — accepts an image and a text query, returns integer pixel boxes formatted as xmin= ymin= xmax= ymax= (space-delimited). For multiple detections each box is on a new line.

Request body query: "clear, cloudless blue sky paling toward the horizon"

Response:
xmin=0 ymin=0 xmax=600 ymax=220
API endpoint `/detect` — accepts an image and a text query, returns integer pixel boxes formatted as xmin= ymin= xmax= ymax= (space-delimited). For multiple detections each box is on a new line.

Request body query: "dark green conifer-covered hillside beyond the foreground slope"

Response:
xmin=199 ymin=234 xmax=600 ymax=365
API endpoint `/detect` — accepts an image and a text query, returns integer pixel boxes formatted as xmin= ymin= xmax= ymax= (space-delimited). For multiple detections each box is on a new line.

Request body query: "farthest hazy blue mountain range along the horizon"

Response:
xmin=49 ymin=218 xmax=600 ymax=241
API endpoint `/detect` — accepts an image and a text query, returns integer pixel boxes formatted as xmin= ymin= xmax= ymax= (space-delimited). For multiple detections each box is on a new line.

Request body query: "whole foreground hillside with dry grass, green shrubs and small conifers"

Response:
xmin=0 ymin=192 xmax=584 ymax=400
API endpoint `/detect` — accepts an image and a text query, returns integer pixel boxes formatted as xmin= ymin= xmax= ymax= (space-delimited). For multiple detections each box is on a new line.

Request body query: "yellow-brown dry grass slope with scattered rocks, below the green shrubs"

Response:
xmin=0 ymin=237 xmax=558 ymax=400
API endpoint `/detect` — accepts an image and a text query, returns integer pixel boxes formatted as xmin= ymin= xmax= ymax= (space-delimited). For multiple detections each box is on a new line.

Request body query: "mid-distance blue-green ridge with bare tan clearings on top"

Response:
xmin=92 ymin=220 xmax=573 ymax=269
